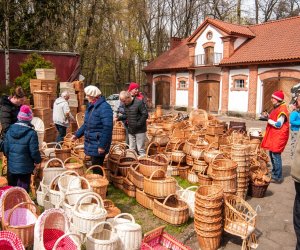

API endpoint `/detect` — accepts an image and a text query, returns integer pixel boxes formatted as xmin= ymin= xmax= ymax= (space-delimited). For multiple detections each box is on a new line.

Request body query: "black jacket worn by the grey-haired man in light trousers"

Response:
xmin=125 ymin=98 xmax=148 ymax=135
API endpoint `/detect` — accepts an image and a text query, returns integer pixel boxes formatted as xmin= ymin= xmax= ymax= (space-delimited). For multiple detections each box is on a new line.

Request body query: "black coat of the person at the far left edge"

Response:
xmin=0 ymin=95 xmax=20 ymax=135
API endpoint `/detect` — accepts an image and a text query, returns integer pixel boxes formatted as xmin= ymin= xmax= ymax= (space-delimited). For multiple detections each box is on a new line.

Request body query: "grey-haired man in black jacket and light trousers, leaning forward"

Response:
xmin=117 ymin=91 xmax=148 ymax=156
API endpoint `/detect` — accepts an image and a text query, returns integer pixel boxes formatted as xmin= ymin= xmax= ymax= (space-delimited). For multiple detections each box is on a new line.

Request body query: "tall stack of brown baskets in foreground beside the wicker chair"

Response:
xmin=194 ymin=185 xmax=223 ymax=250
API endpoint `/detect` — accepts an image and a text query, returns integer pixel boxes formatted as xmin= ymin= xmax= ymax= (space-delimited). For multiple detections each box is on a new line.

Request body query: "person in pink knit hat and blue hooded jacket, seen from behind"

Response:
xmin=4 ymin=105 xmax=42 ymax=192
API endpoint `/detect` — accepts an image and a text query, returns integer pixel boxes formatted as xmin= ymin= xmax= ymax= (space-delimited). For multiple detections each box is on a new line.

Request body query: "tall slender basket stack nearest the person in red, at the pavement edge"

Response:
xmin=231 ymin=144 xmax=250 ymax=199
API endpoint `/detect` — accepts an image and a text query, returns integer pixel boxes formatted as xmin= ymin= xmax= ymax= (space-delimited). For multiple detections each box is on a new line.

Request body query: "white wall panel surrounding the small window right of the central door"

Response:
xmin=228 ymin=69 xmax=249 ymax=112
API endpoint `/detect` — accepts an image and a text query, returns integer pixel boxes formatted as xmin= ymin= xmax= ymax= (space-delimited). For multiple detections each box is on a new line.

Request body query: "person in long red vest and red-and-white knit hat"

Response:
xmin=261 ymin=90 xmax=289 ymax=183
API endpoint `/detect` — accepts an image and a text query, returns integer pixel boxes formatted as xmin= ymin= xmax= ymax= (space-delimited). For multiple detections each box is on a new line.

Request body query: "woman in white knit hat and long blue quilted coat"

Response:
xmin=72 ymin=85 xmax=113 ymax=173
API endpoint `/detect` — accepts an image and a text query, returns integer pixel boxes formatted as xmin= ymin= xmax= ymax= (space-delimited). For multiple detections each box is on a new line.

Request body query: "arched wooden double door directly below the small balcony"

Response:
xmin=196 ymin=74 xmax=220 ymax=112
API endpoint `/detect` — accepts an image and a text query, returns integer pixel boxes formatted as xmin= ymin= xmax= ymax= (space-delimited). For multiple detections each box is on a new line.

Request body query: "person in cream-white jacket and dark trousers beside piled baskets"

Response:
xmin=53 ymin=91 xmax=75 ymax=142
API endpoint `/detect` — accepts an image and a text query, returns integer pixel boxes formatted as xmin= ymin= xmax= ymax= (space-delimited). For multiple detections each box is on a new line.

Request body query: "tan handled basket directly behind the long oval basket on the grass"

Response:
xmin=144 ymin=169 xmax=177 ymax=199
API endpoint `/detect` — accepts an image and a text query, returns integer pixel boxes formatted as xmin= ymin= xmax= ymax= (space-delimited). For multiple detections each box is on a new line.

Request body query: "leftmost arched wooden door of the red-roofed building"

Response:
xmin=153 ymin=76 xmax=171 ymax=108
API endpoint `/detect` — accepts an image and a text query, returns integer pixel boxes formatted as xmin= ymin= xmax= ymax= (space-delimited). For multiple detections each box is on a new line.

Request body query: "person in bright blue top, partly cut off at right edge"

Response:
xmin=290 ymin=96 xmax=300 ymax=159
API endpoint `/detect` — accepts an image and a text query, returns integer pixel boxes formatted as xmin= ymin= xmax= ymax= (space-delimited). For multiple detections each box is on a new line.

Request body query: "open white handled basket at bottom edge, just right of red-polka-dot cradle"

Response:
xmin=86 ymin=221 xmax=120 ymax=250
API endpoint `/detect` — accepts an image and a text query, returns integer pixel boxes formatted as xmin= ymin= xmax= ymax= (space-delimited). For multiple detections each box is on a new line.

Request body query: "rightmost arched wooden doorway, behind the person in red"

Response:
xmin=260 ymin=69 xmax=300 ymax=112
